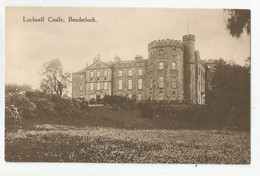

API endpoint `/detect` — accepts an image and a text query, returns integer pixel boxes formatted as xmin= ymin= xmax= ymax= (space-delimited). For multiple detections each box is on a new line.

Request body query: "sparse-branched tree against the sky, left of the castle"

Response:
xmin=40 ymin=59 xmax=70 ymax=97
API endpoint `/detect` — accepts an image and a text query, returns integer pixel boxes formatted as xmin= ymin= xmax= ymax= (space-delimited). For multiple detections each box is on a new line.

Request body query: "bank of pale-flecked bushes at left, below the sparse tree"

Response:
xmin=5 ymin=90 xmax=88 ymax=123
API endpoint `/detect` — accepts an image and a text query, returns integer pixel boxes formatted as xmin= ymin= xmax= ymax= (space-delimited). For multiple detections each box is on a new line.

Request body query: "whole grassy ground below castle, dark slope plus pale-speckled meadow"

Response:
xmin=5 ymin=107 xmax=250 ymax=164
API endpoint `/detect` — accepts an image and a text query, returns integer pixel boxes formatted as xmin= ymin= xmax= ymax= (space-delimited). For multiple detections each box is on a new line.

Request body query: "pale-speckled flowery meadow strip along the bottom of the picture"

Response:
xmin=5 ymin=125 xmax=250 ymax=164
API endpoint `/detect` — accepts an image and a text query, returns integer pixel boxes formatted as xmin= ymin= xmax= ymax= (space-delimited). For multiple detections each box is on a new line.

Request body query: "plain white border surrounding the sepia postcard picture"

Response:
xmin=0 ymin=0 xmax=260 ymax=176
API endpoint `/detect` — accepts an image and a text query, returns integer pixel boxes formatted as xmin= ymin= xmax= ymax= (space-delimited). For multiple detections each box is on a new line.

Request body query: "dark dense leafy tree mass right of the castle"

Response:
xmin=209 ymin=59 xmax=250 ymax=126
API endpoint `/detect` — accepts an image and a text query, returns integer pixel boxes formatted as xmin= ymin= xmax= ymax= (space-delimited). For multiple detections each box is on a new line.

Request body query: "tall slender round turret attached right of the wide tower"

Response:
xmin=183 ymin=34 xmax=196 ymax=103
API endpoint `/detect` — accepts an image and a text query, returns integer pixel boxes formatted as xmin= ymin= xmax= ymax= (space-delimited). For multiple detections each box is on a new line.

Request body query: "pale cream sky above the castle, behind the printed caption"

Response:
xmin=5 ymin=7 xmax=250 ymax=88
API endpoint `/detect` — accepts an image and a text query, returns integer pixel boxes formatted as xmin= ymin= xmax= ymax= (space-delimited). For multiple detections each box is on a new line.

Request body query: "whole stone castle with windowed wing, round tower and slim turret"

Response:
xmin=72 ymin=34 xmax=206 ymax=104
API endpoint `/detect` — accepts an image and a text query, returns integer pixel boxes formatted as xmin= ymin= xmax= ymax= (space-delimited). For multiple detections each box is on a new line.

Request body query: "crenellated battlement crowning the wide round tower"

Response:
xmin=148 ymin=39 xmax=183 ymax=50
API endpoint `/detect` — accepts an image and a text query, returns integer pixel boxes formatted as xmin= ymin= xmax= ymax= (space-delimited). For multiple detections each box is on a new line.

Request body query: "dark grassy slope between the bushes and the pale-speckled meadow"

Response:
xmin=15 ymin=106 xmax=228 ymax=129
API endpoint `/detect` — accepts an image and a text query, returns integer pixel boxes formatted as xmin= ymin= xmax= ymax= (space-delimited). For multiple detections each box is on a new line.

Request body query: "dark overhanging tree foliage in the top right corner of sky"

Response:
xmin=225 ymin=9 xmax=251 ymax=38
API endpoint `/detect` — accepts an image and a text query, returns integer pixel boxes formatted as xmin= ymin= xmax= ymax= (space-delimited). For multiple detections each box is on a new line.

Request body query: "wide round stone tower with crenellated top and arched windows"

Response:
xmin=147 ymin=39 xmax=184 ymax=101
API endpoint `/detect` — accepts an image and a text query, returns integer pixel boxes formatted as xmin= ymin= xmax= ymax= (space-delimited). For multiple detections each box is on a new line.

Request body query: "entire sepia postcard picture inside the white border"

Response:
xmin=4 ymin=6 xmax=251 ymax=165
